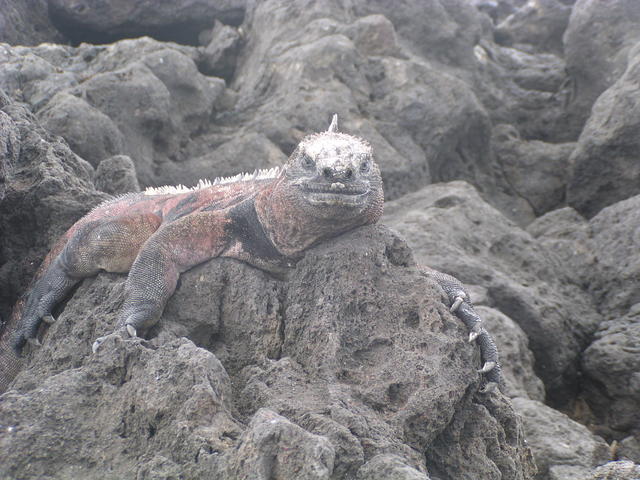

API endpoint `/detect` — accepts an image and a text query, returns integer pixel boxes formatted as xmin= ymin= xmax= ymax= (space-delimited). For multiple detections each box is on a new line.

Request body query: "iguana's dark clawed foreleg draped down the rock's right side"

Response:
xmin=421 ymin=267 xmax=501 ymax=389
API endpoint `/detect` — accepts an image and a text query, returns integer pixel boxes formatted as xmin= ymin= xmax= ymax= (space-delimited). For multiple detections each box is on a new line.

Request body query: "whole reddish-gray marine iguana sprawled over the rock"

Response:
xmin=0 ymin=115 xmax=500 ymax=393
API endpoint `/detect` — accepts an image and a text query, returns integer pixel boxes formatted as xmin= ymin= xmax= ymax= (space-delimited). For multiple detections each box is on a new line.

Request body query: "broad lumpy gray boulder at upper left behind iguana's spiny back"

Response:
xmin=0 ymin=38 xmax=229 ymax=186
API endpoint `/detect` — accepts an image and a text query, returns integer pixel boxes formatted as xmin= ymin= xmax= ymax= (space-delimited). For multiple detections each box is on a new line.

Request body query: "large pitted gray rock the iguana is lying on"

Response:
xmin=0 ymin=227 xmax=533 ymax=479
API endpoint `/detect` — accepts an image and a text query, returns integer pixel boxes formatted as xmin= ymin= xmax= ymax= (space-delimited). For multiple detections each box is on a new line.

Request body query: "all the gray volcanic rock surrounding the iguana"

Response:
xmin=0 ymin=0 xmax=640 ymax=480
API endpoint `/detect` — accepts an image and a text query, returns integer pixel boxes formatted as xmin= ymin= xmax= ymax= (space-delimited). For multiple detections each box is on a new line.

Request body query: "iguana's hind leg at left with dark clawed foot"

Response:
xmin=12 ymin=214 xmax=160 ymax=351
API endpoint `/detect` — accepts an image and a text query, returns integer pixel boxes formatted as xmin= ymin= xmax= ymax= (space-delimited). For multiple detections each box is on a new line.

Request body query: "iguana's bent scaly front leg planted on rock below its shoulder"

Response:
xmin=93 ymin=211 xmax=228 ymax=352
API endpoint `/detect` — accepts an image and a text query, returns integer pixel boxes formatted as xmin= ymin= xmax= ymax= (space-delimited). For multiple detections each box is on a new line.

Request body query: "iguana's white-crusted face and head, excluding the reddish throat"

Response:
xmin=284 ymin=115 xmax=383 ymax=223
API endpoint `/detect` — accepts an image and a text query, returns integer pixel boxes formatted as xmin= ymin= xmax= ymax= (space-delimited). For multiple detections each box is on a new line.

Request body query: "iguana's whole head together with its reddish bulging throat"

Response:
xmin=255 ymin=116 xmax=384 ymax=256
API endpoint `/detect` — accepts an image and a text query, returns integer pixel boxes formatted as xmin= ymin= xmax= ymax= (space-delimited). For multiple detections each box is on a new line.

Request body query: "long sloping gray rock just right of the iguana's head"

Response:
xmin=384 ymin=182 xmax=601 ymax=402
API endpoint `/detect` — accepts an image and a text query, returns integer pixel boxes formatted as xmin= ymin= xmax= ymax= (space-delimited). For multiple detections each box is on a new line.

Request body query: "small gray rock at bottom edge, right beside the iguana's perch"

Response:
xmin=513 ymin=398 xmax=611 ymax=480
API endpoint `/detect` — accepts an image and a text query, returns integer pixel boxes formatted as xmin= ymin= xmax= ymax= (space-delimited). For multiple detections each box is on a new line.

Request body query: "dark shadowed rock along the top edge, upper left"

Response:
xmin=49 ymin=0 xmax=246 ymax=44
